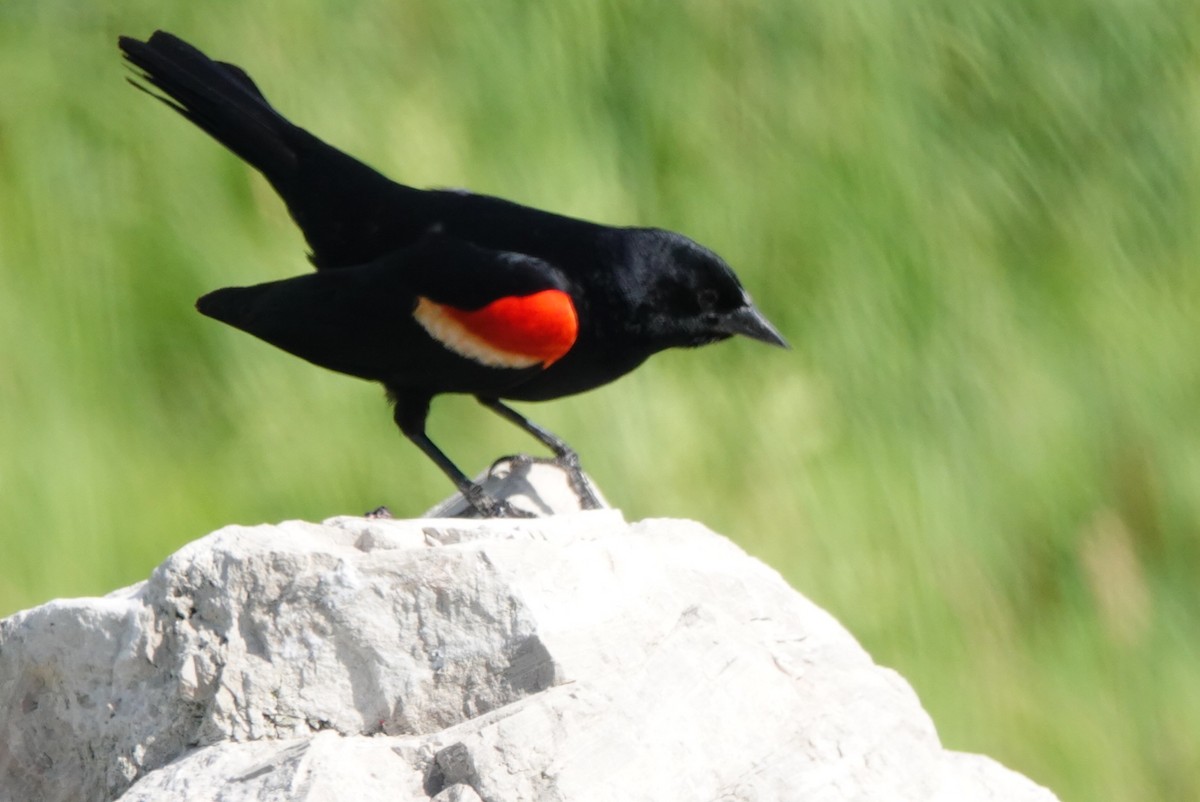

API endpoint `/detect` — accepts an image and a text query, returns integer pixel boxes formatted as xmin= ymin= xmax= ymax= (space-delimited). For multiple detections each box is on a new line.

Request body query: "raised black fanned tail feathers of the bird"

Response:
xmin=119 ymin=31 xmax=304 ymax=184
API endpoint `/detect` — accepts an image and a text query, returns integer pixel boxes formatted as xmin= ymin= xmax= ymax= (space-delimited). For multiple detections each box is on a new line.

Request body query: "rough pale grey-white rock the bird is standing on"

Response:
xmin=0 ymin=466 xmax=1055 ymax=802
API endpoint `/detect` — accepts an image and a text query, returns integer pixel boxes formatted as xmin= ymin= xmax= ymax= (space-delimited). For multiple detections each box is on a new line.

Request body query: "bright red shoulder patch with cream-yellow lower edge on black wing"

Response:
xmin=413 ymin=289 xmax=580 ymax=367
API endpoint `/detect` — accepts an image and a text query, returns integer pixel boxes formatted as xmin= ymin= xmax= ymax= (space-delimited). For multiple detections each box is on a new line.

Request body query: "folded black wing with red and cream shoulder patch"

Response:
xmin=197 ymin=235 xmax=580 ymax=384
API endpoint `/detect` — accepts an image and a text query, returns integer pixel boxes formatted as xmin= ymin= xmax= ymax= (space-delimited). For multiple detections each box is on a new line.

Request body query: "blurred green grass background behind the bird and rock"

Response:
xmin=0 ymin=0 xmax=1200 ymax=801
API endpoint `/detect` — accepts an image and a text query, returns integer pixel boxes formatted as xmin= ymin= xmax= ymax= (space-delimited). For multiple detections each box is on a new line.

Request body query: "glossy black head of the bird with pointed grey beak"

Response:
xmin=638 ymin=229 xmax=788 ymax=348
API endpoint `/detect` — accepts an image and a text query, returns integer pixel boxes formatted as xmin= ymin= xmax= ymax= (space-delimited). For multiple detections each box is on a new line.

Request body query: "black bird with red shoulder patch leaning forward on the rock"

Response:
xmin=120 ymin=31 xmax=786 ymax=515
